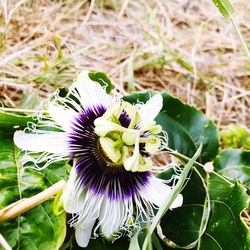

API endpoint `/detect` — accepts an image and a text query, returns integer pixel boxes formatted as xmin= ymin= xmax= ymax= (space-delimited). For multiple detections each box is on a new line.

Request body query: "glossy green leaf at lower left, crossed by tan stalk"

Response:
xmin=0 ymin=132 xmax=67 ymax=250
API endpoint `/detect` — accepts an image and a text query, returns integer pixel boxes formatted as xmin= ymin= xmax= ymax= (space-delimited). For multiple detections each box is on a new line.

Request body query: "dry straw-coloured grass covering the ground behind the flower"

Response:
xmin=0 ymin=0 xmax=250 ymax=128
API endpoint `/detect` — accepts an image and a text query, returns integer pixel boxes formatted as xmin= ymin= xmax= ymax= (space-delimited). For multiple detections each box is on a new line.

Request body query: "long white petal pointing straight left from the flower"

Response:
xmin=14 ymin=130 xmax=69 ymax=156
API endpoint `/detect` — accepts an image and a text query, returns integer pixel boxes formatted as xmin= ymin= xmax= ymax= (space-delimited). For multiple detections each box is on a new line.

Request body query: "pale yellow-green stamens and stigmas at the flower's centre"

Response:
xmin=94 ymin=102 xmax=162 ymax=172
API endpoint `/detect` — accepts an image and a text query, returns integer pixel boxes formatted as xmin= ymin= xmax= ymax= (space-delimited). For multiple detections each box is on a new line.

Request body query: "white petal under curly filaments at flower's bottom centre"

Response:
xmin=99 ymin=197 xmax=127 ymax=238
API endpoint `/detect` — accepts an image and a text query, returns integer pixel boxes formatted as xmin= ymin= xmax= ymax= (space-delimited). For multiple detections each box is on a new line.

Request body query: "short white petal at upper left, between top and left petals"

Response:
xmin=48 ymin=104 xmax=77 ymax=132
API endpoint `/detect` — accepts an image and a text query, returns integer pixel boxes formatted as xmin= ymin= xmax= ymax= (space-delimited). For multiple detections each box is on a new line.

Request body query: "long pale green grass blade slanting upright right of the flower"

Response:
xmin=142 ymin=144 xmax=202 ymax=250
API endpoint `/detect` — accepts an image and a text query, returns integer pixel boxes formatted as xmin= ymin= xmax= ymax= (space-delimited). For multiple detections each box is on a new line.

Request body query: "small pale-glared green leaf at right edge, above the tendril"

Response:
xmin=214 ymin=149 xmax=250 ymax=188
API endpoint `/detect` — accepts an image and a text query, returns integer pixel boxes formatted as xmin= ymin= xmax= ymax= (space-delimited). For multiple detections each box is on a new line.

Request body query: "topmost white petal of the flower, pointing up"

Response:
xmin=74 ymin=71 xmax=115 ymax=109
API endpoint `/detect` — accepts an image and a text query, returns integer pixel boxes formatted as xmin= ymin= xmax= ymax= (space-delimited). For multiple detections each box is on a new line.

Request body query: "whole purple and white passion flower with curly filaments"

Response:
xmin=14 ymin=72 xmax=182 ymax=247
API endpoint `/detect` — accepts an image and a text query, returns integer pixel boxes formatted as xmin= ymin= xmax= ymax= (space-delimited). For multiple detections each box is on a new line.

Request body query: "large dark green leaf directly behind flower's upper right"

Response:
xmin=124 ymin=92 xmax=219 ymax=162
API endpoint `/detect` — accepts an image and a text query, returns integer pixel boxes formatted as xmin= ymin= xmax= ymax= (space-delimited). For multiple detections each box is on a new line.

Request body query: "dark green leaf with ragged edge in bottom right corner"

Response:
xmin=197 ymin=174 xmax=250 ymax=250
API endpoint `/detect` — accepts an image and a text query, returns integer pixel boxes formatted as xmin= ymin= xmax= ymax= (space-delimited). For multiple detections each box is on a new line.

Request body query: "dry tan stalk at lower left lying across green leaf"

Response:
xmin=0 ymin=180 xmax=66 ymax=222
